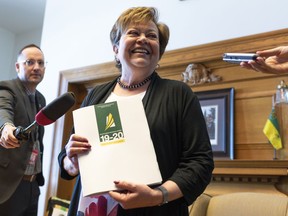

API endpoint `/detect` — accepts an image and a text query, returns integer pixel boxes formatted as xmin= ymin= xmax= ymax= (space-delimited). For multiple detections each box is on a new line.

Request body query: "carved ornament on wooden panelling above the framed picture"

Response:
xmin=181 ymin=63 xmax=222 ymax=85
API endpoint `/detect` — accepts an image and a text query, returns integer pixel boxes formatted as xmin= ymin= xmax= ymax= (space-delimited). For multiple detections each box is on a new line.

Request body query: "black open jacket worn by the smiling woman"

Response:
xmin=58 ymin=73 xmax=214 ymax=216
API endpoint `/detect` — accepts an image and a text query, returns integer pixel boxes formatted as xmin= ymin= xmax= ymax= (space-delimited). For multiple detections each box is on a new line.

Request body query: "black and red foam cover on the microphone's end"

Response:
xmin=35 ymin=92 xmax=75 ymax=126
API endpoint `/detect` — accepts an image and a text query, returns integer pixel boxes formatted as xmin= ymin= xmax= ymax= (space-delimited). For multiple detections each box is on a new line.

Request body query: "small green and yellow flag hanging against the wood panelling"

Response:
xmin=263 ymin=108 xmax=282 ymax=149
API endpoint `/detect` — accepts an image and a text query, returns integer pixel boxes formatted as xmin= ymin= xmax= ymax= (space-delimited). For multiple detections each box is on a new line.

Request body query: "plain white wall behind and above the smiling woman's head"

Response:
xmin=39 ymin=0 xmax=288 ymax=215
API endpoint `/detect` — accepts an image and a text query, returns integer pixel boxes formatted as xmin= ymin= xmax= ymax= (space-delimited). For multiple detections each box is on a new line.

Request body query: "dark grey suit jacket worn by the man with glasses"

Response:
xmin=0 ymin=79 xmax=46 ymax=204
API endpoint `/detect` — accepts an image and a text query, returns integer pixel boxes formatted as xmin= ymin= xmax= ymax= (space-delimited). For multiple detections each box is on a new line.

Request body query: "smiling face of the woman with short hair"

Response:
xmin=114 ymin=21 xmax=160 ymax=72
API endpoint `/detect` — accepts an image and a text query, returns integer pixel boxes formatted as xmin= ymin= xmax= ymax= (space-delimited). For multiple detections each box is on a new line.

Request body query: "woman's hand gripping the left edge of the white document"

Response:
xmin=63 ymin=134 xmax=91 ymax=176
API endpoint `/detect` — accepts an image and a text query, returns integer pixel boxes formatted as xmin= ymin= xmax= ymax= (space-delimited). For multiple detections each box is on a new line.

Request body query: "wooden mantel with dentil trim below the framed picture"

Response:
xmin=205 ymin=160 xmax=288 ymax=196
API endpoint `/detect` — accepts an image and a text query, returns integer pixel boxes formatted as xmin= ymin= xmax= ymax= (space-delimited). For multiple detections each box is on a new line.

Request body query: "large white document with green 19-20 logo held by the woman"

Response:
xmin=73 ymin=98 xmax=162 ymax=196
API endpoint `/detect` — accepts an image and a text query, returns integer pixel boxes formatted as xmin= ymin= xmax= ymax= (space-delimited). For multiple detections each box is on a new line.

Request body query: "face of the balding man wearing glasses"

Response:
xmin=15 ymin=47 xmax=45 ymax=88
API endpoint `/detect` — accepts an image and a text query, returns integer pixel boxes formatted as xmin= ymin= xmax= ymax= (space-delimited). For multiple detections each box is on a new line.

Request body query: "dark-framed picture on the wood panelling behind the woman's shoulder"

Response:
xmin=195 ymin=88 xmax=234 ymax=160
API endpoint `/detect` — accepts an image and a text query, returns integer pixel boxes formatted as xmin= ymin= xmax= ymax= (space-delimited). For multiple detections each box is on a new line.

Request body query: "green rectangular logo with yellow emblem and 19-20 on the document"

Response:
xmin=94 ymin=102 xmax=125 ymax=145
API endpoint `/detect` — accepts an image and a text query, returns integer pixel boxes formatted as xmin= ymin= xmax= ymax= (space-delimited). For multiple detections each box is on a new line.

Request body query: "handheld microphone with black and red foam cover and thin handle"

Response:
xmin=14 ymin=92 xmax=75 ymax=140
